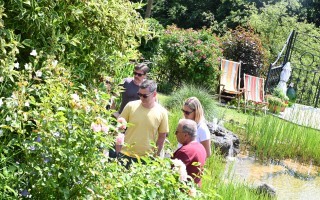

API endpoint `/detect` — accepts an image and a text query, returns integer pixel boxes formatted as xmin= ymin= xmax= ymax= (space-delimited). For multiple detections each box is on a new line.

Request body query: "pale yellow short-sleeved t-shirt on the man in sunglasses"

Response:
xmin=120 ymin=100 xmax=169 ymax=157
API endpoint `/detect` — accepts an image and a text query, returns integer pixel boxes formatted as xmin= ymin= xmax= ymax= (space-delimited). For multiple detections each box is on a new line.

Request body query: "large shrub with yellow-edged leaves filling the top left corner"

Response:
xmin=5 ymin=0 xmax=149 ymax=83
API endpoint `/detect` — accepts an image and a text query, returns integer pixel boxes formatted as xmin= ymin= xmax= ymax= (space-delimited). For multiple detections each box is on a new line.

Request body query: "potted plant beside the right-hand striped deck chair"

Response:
xmin=267 ymin=88 xmax=289 ymax=113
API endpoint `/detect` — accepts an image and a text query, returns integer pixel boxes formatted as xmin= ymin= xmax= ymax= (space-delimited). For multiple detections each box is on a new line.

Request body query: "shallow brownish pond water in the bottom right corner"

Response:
xmin=227 ymin=155 xmax=320 ymax=200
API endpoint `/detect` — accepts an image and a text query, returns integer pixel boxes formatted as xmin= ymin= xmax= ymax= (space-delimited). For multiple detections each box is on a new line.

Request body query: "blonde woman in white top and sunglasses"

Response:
xmin=178 ymin=97 xmax=211 ymax=158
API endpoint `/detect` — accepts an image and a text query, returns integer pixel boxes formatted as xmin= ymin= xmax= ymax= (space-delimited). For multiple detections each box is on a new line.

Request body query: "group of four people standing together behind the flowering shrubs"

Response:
xmin=109 ymin=64 xmax=211 ymax=185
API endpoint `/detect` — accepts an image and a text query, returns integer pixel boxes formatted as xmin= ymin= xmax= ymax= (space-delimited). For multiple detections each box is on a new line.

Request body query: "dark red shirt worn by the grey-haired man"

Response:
xmin=173 ymin=141 xmax=207 ymax=186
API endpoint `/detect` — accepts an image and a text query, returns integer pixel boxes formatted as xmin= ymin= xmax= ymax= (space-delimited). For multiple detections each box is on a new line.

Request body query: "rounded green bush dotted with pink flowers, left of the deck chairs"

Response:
xmin=153 ymin=26 xmax=221 ymax=93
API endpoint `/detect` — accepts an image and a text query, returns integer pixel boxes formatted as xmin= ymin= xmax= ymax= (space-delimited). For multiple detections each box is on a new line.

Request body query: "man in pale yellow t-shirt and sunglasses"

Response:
xmin=119 ymin=80 xmax=169 ymax=167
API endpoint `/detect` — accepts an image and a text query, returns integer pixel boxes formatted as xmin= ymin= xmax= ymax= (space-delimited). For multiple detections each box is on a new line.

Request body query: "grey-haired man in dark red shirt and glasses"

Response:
xmin=172 ymin=119 xmax=207 ymax=186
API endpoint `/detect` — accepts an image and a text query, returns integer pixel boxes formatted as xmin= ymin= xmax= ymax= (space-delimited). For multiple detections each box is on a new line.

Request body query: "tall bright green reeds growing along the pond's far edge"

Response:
xmin=245 ymin=115 xmax=320 ymax=165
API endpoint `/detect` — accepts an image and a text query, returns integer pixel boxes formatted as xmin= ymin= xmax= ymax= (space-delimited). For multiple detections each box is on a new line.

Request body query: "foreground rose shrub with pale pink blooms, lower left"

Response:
xmin=0 ymin=48 xmax=200 ymax=199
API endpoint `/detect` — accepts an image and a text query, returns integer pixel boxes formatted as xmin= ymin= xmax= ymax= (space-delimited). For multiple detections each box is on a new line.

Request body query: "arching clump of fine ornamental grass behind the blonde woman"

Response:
xmin=164 ymin=84 xmax=220 ymax=121
